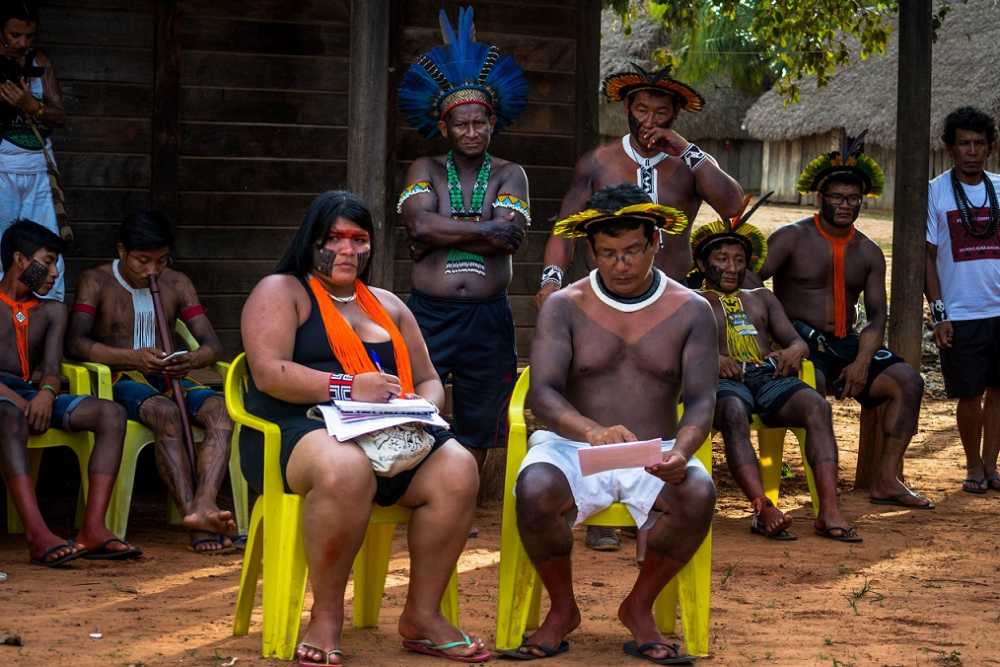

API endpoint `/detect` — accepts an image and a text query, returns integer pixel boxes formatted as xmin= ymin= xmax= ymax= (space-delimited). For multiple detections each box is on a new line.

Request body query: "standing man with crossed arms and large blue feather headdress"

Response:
xmin=397 ymin=8 xmax=531 ymax=496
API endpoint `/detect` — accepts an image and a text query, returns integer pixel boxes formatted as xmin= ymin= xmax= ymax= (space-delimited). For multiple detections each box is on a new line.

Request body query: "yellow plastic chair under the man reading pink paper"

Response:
xmin=496 ymin=368 xmax=712 ymax=656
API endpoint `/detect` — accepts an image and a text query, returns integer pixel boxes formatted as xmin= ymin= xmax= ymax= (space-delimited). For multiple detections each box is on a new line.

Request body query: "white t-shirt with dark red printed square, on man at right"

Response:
xmin=927 ymin=169 xmax=1000 ymax=320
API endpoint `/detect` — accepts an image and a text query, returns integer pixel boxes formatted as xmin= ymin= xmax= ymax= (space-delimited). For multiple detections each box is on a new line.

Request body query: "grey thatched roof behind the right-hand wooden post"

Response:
xmin=744 ymin=0 xmax=1000 ymax=148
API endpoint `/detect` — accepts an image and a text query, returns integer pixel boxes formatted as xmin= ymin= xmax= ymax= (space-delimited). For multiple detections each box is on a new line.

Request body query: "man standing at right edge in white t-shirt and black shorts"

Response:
xmin=926 ymin=107 xmax=1000 ymax=494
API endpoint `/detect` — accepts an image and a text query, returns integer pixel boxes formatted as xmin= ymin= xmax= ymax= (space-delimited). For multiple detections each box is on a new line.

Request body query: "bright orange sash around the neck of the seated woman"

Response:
xmin=309 ymin=276 xmax=414 ymax=394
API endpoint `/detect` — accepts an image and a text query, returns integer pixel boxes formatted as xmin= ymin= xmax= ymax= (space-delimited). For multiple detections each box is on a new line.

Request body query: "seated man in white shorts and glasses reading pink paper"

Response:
xmin=510 ymin=184 xmax=719 ymax=661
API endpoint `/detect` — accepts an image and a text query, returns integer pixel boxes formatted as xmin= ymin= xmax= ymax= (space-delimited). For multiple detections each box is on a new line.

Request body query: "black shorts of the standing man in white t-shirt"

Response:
xmin=941 ymin=317 xmax=1000 ymax=398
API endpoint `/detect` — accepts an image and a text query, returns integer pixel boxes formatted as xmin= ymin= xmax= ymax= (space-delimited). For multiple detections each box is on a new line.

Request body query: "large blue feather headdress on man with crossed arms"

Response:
xmin=399 ymin=7 xmax=528 ymax=138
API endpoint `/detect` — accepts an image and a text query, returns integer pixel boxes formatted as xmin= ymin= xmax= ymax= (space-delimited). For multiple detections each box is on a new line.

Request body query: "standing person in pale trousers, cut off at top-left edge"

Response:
xmin=0 ymin=1 xmax=68 ymax=301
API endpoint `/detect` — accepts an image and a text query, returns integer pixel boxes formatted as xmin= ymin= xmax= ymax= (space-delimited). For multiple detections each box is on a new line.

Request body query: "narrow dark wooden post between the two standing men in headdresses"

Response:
xmin=574 ymin=0 xmax=601 ymax=158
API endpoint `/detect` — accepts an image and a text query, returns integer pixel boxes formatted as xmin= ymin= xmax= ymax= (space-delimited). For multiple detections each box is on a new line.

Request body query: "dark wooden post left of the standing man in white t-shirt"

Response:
xmin=854 ymin=0 xmax=931 ymax=488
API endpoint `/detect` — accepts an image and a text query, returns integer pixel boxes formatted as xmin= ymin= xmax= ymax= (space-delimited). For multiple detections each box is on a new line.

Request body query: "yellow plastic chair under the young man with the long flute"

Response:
xmin=65 ymin=320 xmax=249 ymax=540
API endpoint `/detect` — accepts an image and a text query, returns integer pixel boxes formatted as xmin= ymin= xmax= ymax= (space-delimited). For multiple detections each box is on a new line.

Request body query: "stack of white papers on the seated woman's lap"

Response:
xmin=309 ymin=398 xmax=448 ymax=442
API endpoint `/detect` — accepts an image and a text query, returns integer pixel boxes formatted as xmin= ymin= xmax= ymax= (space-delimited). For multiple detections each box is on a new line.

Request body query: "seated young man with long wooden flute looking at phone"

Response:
xmin=66 ymin=211 xmax=236 ymax=553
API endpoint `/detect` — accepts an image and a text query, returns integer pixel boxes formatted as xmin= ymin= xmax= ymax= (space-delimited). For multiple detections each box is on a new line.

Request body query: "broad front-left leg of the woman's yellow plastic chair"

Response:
xmin=261 ymin=495 xmax=309 ymax=660
